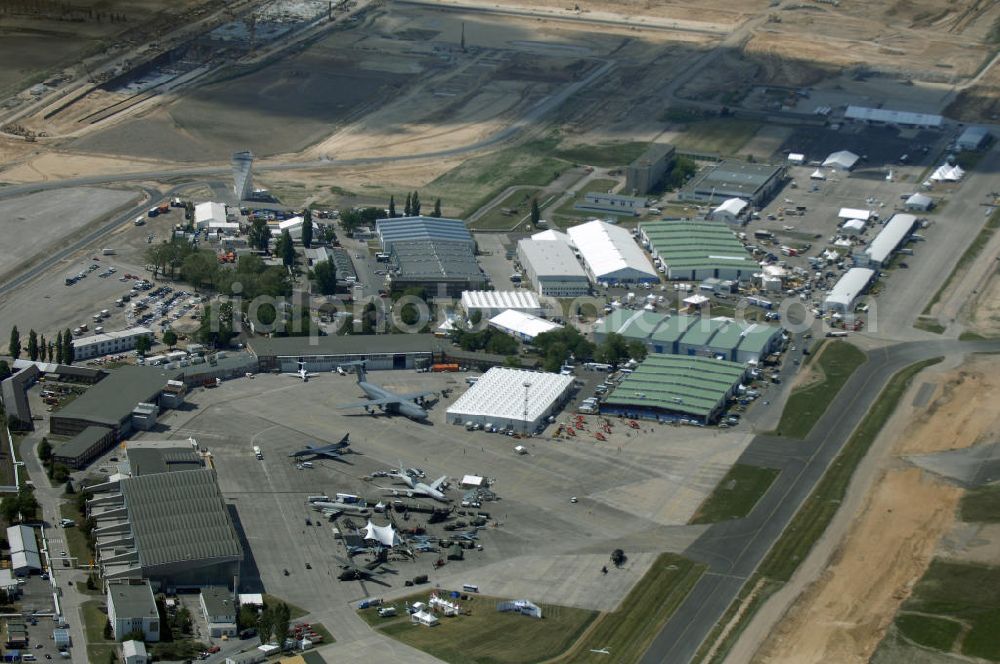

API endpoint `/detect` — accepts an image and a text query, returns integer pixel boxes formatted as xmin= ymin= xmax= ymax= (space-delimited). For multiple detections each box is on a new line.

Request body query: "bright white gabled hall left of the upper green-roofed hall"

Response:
xmin=566 ymin=221 xmax=660 ymax=284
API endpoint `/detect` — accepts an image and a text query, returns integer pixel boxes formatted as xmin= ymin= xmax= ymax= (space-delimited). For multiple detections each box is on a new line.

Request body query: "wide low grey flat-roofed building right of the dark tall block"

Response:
xmin=677 ymin=161 xmax=785 ymax=208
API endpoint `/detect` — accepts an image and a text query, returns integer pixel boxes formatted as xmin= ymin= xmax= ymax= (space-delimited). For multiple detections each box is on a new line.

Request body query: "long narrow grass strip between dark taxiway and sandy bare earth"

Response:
xmin=758 ymin=358 xmax=941 ymax=581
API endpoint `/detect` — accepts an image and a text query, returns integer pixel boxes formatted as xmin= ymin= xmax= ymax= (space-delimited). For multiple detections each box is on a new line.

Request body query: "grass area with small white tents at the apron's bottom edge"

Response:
xmin=379 ymin=593 xmax=597 ymax=664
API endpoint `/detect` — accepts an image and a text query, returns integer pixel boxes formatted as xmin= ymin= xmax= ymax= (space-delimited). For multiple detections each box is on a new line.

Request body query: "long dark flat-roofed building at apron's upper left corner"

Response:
xmin=49 ymin=366 xmax=181 ymax=440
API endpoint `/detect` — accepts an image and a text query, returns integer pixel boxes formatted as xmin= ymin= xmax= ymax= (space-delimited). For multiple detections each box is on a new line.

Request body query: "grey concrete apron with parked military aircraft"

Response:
xmin=143 ymin=371 xmax=748 ymax=616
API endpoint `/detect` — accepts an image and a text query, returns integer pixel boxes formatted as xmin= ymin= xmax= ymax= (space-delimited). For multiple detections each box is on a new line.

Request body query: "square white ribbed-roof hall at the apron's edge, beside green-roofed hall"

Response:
xmin=447 ymin=367 xmax=573 ymax=433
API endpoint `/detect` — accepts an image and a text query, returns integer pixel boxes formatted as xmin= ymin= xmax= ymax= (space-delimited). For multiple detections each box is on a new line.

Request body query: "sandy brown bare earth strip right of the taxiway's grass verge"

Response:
xmin=752 ymin=356 xmax=1000 ymax=664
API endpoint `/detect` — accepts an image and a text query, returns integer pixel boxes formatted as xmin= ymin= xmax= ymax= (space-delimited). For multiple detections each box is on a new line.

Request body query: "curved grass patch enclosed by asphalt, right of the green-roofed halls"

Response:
xmin=775 ymin=341 xmax=867 ymax=438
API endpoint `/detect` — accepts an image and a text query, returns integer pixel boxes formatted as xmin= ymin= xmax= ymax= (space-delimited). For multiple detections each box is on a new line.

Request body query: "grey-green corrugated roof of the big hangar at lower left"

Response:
xmin=120 ymin=469 xmax=243 ymax=567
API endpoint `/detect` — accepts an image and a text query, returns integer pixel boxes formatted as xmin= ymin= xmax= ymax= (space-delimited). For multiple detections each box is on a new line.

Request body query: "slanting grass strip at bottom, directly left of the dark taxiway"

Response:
xmin=554 ymin=553 xmax=706 ymax=664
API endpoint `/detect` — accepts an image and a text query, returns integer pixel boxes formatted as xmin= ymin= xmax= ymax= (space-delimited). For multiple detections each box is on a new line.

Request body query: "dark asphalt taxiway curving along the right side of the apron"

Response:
xmin=641 ymin=340 xmax=1000 ymax=664
